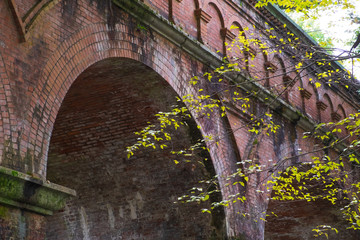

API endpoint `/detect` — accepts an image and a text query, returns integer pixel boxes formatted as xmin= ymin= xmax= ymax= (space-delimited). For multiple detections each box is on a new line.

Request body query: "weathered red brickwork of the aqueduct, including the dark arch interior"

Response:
xmin=0 ymin=0 xmax=358 ymax=239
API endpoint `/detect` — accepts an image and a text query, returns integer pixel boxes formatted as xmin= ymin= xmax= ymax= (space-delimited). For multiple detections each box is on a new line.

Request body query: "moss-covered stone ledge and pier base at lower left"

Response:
xmin=0 ymin=167 xmax=76 ymax=240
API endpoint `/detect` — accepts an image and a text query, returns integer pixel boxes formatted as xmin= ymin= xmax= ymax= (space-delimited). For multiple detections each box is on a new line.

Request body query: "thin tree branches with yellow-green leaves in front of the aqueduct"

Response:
xmin=128 ymin=0 xmax=360 ymax=236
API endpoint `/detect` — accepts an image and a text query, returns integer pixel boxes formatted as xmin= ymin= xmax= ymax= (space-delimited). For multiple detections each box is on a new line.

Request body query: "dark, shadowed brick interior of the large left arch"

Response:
xmin=46 ymin=58 xmax=223 ymax=240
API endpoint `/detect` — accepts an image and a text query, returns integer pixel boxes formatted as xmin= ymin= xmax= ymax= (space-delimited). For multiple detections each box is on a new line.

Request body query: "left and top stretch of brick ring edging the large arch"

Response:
xmin=27 ymin=24 xmax=187 ymax=177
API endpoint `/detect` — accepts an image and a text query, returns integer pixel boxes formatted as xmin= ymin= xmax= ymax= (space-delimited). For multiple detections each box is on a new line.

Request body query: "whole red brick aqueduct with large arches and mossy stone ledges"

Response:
xmin=0 ymin=0 xmax=358 ymax=240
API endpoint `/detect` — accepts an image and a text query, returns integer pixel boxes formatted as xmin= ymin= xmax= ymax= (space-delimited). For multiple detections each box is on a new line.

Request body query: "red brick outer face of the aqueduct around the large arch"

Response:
xmin=0 ymin=0 xmax=356 ymax=240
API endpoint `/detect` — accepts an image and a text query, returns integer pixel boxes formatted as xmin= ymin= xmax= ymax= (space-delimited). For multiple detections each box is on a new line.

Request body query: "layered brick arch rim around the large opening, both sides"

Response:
xmin=24 ymin=23 xmax=249 ymax=240
